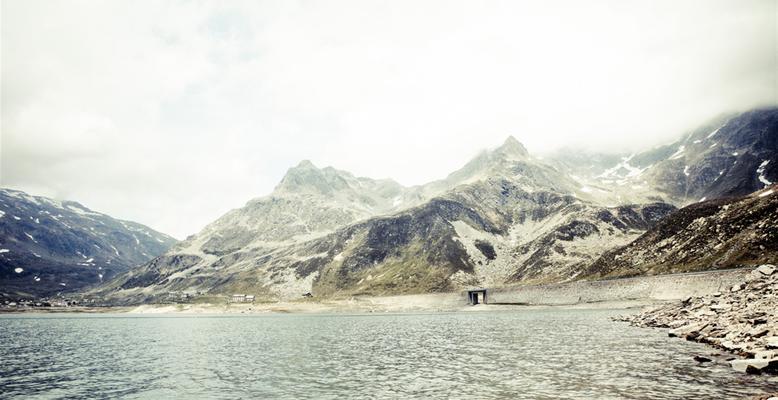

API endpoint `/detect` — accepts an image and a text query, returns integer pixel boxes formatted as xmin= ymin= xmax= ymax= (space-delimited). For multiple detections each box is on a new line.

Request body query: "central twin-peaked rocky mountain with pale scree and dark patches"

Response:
xmin=92 ymin=138 xmax=674 ymax=302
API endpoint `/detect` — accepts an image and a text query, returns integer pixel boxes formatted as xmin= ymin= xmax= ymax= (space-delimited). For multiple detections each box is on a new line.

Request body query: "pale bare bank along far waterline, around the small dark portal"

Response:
xmin=123 ymin=269 xmax=750 ymax=314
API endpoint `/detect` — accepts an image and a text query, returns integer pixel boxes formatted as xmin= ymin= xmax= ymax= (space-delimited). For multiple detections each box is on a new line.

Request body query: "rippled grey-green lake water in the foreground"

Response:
xmin=0 ymin=310 xmax=778 ymax=399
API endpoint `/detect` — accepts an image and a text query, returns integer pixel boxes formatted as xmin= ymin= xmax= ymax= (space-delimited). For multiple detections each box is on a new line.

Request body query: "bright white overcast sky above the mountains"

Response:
xmin=0 ymin=0 xmax=778 ymax=239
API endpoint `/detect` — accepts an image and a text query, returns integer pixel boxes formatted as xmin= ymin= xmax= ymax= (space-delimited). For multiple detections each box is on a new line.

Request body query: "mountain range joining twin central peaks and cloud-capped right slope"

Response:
xmin=97 ymin=109 xmax=778 ymax=303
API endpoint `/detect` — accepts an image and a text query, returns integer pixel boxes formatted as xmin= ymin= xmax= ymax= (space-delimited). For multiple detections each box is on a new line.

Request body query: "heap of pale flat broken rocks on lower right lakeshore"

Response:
xmin=617 ymin=264 xmax=778 ymax=375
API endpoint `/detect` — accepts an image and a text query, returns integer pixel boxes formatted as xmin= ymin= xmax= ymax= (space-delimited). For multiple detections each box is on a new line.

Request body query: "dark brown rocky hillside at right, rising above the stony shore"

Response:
xmin=586 ymin=185 xmax=778 ymax=278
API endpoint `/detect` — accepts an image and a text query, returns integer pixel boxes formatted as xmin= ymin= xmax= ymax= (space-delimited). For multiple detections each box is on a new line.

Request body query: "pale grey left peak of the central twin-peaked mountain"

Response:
xmin=173 ymin=161 xmax=411 ymax=260
